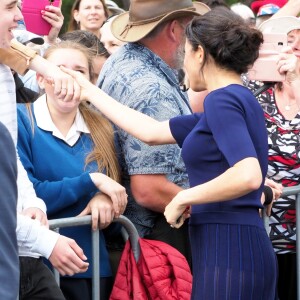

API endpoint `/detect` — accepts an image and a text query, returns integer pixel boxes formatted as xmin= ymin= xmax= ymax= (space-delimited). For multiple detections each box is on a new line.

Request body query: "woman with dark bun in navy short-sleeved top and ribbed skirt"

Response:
xmin=64 ymin=8 xmax=277 ymax=300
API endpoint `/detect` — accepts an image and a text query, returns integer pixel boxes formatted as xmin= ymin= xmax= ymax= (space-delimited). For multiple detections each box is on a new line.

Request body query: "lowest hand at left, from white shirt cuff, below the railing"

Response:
xmin=49 ymin=236 xmax=89 ymax=276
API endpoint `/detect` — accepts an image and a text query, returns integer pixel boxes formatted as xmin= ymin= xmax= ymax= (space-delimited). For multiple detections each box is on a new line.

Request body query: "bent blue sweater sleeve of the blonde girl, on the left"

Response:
xmin=17 ymin=107 xmax=98 ymax=214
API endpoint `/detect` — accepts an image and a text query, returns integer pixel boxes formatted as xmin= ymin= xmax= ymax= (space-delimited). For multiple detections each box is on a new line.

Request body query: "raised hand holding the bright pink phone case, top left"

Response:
xmin=42 ymin=5 xmax=64 ymax=44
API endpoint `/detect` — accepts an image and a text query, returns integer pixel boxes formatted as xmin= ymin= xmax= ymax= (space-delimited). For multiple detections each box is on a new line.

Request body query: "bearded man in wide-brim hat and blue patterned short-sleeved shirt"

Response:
xmin=98 ymin=0 xmax=209 ymax=270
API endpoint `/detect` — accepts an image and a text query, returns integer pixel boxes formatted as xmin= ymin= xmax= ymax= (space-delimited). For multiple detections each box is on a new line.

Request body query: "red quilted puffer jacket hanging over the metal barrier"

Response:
xmin=110 ymin=239 xmax=192 ymax=300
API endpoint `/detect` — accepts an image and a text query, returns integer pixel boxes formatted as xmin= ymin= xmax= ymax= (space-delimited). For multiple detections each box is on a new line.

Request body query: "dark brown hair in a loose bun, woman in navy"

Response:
xmin=186 ymin=7 xmax=263 ymax=74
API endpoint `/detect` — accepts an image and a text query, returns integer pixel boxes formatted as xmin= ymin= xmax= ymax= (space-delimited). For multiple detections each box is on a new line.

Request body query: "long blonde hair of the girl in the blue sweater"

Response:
xmin=35 ymin=41 xmax=121 ymax=182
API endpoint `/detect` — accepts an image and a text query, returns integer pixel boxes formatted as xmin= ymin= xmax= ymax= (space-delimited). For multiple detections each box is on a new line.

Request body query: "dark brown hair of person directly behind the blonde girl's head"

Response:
xmin=60 ymin=30 xmax=110 ymax=58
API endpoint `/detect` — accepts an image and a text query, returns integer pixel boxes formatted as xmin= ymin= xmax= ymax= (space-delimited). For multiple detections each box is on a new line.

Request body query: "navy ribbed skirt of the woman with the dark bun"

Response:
xmin=190 ymin=224 xmax=277 ymax=300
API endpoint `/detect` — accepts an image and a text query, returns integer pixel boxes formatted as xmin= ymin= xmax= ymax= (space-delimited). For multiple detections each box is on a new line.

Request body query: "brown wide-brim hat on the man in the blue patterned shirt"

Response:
xmin=111 ymin=0 xmax=210 ymax=42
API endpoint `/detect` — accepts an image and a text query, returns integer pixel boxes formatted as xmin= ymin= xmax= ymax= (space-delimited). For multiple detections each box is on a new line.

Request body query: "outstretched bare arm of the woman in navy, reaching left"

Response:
xmin=61 ymin=66 xmax=175 ymax=145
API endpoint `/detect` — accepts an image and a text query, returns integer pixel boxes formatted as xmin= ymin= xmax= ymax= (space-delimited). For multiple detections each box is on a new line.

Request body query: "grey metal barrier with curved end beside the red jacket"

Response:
xmin=49 ymin=216 xmax=140 ymax=300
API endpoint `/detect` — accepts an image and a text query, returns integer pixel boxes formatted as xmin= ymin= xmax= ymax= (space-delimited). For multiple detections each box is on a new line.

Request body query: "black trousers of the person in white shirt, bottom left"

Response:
xmin=19 ymin=257 xmax=65 ymax=300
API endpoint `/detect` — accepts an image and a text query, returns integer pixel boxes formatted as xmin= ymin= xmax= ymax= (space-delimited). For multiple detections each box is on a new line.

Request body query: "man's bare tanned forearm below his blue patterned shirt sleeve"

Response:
xmin=130 ymin=174 xmax=182 ymax=213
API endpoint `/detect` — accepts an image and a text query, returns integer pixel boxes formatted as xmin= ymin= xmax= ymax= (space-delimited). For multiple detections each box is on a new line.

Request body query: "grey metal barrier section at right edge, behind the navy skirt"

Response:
xmin=264 ymin=185 xmax=300 ymax=300
